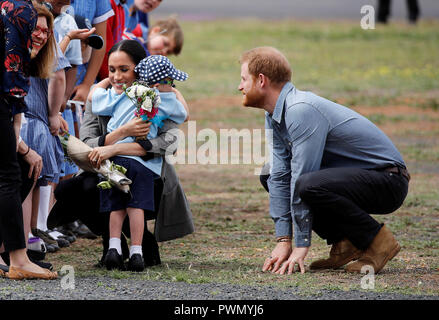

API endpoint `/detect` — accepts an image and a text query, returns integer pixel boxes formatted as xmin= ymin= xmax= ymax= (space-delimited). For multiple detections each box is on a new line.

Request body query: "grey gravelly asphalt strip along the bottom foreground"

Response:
xmin=0 ymin=277 xmax=439 ymax=301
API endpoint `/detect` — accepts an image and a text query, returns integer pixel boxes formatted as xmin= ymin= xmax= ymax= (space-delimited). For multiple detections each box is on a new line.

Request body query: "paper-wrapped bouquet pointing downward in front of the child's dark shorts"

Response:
xmin=59 ymin=132 xmax=131 ymax=193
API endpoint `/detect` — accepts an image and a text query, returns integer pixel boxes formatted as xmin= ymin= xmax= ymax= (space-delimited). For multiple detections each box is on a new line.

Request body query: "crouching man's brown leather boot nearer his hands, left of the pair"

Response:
xmin=310 ymin=239 xmax=362 ymax=270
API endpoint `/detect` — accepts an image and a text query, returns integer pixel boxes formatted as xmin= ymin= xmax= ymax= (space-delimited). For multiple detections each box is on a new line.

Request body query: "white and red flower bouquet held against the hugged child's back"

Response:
xmin=124 ymin=81 xmax=163 ymax=140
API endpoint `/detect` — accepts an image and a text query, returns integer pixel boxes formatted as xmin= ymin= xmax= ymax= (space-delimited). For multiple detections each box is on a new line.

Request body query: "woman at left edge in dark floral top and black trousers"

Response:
xmin=0 ymin=0 xmax=57 ymax=280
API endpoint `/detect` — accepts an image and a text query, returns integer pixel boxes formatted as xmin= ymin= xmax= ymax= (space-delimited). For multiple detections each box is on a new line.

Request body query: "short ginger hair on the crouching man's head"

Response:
xmin=239 ymin=47 xmax=292 ymax=85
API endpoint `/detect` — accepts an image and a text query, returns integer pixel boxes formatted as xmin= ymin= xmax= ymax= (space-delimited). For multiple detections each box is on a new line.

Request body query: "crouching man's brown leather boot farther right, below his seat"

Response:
xmin=346 ymin=226 xmax=401 ymax=274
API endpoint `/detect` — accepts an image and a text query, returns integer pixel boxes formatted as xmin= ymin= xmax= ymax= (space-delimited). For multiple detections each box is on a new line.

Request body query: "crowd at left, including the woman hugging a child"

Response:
xmin=0 ymin=0 xmax=194 ymax=279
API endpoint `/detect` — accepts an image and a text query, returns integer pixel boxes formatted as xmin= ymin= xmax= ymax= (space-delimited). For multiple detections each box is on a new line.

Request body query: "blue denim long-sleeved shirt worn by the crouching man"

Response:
xmin=265 ymin=82 xmax=405 ymax=247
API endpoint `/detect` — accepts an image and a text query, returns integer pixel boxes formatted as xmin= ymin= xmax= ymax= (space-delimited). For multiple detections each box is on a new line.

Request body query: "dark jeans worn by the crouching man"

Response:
xmin=296 ymin=168 xmax=408 ymax=250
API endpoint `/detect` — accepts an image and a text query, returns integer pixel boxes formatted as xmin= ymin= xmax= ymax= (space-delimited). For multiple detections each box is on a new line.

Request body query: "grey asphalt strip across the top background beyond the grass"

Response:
xmin=156 ymin=0 xmax=439 ymax=20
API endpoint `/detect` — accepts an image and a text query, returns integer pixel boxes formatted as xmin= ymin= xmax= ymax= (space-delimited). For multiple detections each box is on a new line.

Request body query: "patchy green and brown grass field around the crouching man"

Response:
xmin=48 ymin=20 xmax=439 ymax=295
